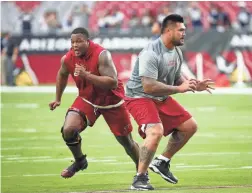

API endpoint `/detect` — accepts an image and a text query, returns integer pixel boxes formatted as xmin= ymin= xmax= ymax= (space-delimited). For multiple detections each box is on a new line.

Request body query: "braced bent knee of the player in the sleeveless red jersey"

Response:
xmin=61 ymin=127 xmax=81 ymax=146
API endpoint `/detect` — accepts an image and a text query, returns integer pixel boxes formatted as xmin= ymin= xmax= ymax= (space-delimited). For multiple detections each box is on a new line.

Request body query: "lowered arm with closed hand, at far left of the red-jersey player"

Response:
xmin=49 ymin=55 xmax=69 ymax=110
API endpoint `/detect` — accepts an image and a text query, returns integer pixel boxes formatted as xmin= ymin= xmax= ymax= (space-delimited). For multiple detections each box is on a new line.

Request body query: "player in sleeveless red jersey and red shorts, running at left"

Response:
xmin=49 ymin=28 xmax=139 ymax=178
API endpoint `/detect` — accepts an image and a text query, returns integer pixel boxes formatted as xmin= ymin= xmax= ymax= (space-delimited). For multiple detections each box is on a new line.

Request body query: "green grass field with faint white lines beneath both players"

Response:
xmin=1 ymin=87 xmax=252 ymax=193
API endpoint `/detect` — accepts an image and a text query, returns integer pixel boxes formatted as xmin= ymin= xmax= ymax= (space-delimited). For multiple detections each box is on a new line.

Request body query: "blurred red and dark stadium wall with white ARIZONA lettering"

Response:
xmin=12 ymin=31 xmax=252 ymax=86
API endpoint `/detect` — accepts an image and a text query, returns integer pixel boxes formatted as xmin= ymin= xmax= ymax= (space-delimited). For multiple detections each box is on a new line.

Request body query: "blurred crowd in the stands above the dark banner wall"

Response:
xmin=1 ymin=1 xmax=252 ymax=34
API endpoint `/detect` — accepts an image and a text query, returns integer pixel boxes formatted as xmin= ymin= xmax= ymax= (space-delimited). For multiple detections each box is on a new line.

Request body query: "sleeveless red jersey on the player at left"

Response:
xmin=65 ymin=40 xmax=124 ymax=107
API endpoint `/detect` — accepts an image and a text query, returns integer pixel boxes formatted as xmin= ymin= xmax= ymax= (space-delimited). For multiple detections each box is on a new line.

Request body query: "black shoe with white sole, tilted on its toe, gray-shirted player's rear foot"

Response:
xmin=149 ymin=157 xmax=178 ymax=184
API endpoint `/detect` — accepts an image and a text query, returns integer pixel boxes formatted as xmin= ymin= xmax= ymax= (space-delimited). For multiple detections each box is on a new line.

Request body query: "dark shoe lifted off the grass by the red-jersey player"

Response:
xmin=61 ymin=155 xmax=88 ymax=178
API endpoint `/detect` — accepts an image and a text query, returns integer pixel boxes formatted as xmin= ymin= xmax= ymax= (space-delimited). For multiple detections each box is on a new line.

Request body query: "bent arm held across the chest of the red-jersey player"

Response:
xmin=77 ymin=50 xmax=117 ymax=89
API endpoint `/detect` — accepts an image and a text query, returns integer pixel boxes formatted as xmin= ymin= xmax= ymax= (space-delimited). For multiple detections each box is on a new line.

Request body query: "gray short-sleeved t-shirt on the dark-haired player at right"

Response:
xmin=126 ymin=38 xmax=183 ymax=101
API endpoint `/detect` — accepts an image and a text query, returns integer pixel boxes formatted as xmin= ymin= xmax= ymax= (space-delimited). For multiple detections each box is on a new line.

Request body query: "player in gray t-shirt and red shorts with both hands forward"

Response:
xmin=125 ymin=14 xmax=213 ymax=190
